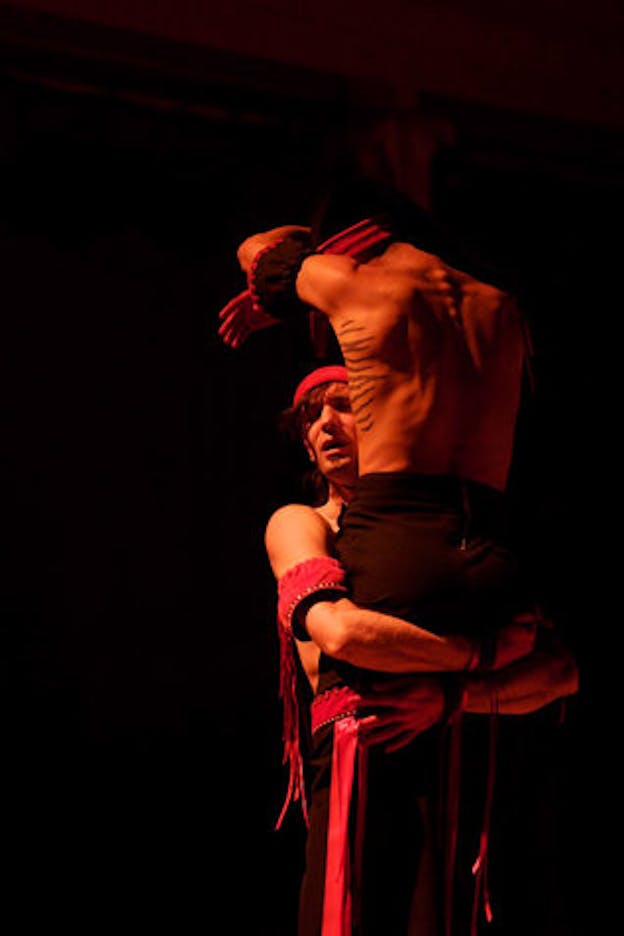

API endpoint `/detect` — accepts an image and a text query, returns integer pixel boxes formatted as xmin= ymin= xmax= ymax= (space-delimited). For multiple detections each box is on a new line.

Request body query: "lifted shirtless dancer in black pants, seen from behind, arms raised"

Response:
xmin=220 ymin=176 xmax=526 ymax=656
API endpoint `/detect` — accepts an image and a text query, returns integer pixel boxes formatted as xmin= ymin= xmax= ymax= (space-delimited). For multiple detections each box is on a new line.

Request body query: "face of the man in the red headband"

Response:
xmin=304 ymin=383 xmax=357 ymax=484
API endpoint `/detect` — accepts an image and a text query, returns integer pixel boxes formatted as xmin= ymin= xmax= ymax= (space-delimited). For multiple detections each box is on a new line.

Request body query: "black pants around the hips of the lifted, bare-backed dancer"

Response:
xmin=336 ymin=473 xmax=519 ymax=634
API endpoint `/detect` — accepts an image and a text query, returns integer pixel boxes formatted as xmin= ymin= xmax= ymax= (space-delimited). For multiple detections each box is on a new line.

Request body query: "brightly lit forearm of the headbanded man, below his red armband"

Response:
xmin=305 ymin=599 xmax=475 ymax=673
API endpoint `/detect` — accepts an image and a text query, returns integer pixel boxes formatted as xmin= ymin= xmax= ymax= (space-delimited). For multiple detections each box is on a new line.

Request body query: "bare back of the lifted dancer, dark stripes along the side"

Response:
xmin=298 ymin=244 xmax=524 ymax=490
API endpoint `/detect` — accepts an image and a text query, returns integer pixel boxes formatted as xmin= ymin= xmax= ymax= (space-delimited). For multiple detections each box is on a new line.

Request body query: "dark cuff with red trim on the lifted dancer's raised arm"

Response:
xmin=248 ymin=231 xmax=314 ymax=321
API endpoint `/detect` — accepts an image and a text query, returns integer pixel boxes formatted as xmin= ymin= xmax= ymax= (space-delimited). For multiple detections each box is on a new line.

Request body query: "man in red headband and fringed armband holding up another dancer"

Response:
xmin=266 ymin=367 xmax=577 ymax=936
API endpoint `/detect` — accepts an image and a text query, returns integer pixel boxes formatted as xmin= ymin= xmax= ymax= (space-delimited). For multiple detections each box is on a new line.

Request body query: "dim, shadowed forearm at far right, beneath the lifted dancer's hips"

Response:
xmin=466 ymin=650 xmax=579 ymax=715
